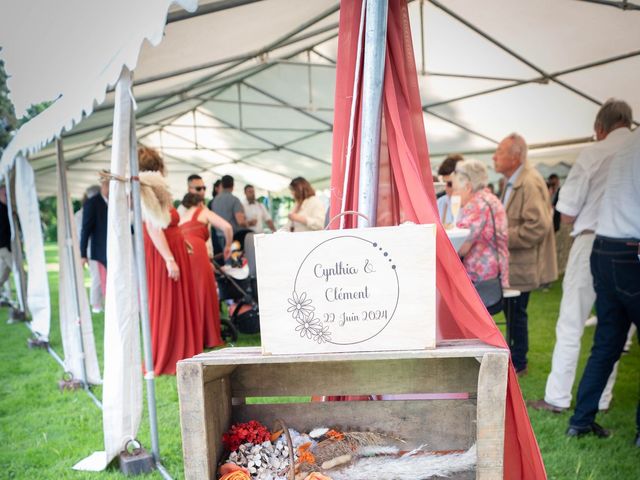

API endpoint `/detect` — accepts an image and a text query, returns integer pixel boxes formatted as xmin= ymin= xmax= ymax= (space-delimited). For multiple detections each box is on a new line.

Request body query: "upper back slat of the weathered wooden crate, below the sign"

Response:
xmin=230 ymin=358 xmax=480 ymax=397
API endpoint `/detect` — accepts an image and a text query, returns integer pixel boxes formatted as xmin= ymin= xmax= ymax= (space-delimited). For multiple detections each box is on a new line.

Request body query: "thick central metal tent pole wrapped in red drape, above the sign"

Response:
xmin=358 ymin=0 xmax=388 ymax=228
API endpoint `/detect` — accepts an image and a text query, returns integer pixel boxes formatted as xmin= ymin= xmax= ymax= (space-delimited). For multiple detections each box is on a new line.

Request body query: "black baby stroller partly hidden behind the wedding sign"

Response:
xmin=213 ymin=232 xmax=260 ymax=342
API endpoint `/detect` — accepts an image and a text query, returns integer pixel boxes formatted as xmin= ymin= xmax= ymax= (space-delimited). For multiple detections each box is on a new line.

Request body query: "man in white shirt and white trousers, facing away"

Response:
xmin=530 ymin=99 xmax=633 ymax=413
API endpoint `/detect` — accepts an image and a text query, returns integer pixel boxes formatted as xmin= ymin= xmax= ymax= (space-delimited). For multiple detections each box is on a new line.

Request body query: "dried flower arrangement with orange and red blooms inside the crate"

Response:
xmin=220 ymin=422 xmax=476 ymax=480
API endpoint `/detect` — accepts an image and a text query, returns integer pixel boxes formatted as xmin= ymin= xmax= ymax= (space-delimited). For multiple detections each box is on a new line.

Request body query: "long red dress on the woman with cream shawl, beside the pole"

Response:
xmin=144 ymin=208 xmax=202 ymax=375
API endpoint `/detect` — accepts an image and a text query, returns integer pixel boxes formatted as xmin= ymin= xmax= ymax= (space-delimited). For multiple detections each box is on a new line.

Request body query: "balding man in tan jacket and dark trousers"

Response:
xmin=493 ymin=133 xmax=558 ymax=376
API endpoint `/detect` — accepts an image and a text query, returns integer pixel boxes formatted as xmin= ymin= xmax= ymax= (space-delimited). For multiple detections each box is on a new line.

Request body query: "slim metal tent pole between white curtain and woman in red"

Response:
xmin=129 ymin=104 xmax=162 ymax=473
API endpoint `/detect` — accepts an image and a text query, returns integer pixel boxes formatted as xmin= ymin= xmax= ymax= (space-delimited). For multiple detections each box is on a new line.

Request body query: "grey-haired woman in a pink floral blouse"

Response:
xmin=453 ymin=160 xmax=509 ymax=287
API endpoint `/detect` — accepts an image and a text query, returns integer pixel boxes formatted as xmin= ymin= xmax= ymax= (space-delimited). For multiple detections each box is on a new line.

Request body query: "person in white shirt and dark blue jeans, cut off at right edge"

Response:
xmin=567 ymin=130 xmax=640 ymax=448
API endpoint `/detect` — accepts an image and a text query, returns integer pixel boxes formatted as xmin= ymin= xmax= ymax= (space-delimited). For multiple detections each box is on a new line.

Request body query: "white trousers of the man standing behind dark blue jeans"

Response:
xmin=544 ymin=234 xmax=618 ymax=410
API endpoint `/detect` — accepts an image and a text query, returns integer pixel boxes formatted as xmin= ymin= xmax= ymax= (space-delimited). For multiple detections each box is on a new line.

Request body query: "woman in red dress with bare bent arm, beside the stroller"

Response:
xmin=180 ymin=193 xmax=233 ymax=348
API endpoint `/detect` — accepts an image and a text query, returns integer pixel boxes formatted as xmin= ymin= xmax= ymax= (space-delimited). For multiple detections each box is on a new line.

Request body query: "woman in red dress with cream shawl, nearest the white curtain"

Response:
xmin=138 ymin=147 xmax=203 ymax=375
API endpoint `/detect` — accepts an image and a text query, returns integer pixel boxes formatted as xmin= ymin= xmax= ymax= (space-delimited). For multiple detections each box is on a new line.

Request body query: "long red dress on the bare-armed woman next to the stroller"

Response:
xmin=180 ymin=204 xmax=224 ymax=347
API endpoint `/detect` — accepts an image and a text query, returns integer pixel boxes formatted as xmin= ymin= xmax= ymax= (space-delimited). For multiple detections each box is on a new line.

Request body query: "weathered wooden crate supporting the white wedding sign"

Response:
xmin=178 ymin=340 xmax=509 ymax=480
